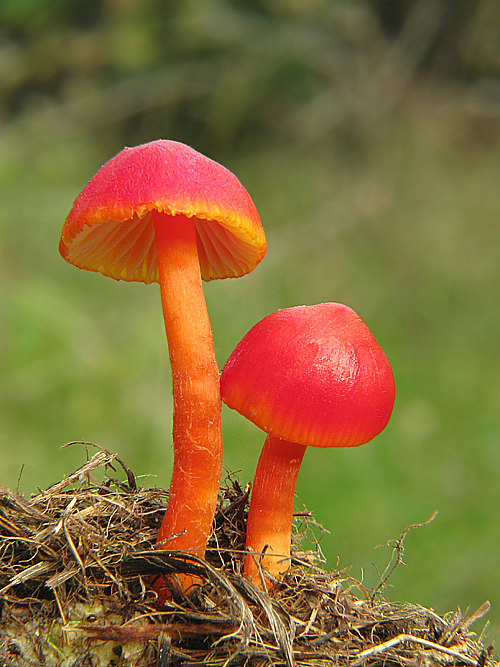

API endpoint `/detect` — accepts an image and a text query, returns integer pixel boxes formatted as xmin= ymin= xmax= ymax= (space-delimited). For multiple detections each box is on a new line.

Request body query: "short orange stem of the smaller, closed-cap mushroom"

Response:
xmin=244 ymin=435 xmax=306 ymax=586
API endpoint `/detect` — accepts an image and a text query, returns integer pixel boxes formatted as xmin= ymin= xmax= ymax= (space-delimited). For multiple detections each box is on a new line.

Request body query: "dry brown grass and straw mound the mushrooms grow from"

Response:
xmin=0 ymin=448 xmax=496 ymax=667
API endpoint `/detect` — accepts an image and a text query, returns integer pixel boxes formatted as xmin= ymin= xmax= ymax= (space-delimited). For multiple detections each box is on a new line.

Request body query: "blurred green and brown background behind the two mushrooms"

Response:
xmin=0 ymin=0 xmax=500 ymax=640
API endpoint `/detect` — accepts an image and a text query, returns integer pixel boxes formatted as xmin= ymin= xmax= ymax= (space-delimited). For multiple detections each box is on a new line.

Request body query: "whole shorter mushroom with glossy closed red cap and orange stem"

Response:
xmin=221 ymin=303 xmax=395 ymax=586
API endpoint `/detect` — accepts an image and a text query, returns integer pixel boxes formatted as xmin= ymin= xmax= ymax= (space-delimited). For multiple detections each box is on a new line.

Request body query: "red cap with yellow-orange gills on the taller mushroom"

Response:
xmin=59 ymin=139 xmax=266 ymax=283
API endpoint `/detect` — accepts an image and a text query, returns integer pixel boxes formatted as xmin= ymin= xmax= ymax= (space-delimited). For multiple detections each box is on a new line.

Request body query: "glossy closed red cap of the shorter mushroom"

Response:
xmin=221 ymin=303 xmax=395 ymax=447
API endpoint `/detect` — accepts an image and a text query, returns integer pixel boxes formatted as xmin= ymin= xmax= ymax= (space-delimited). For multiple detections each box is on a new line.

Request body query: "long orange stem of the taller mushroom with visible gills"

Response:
xmin=152 ymin=211 xmax=222 ymax=557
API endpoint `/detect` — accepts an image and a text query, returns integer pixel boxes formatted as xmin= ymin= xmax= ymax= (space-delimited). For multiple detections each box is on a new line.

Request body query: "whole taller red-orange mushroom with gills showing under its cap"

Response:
xmin=59 ymin=140 xmax=266 ymax=556
